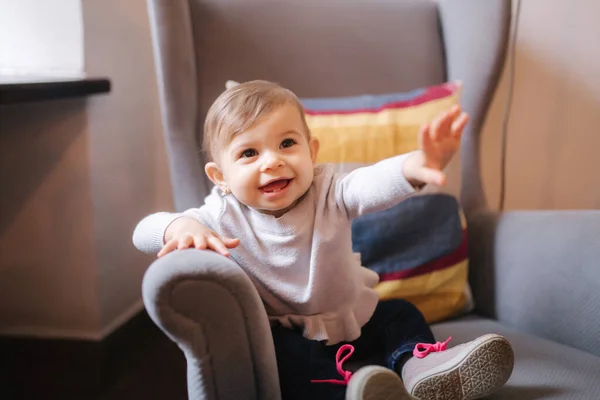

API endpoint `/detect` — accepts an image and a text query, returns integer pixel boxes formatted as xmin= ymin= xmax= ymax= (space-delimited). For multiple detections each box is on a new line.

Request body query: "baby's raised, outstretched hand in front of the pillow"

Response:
xmin=404 ymin=105 xmax=469 ymax=186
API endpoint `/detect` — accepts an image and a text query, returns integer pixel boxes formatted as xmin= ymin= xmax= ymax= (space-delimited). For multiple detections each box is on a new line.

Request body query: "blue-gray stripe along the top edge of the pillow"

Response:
xmin=300 ymin=89 xmax=425 ymax=111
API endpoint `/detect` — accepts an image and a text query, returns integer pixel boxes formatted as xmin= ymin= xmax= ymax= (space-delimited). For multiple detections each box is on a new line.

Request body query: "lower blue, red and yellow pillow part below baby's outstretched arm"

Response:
xmin=352 ymin=194 xmax=472 ymax=322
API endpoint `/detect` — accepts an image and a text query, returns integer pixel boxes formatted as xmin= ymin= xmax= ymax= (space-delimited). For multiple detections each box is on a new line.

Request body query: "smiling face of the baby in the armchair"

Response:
xmin=219 ymin=104 xmax=318 ymax=217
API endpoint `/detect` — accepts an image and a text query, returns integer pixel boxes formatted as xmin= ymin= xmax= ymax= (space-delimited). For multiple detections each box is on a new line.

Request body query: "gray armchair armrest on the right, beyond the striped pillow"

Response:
xmin=469 ymin=210 xmax=600 ymax=355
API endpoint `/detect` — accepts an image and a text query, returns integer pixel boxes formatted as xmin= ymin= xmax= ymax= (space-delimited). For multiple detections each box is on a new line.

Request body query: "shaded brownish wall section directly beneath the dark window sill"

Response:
xmin=0 ymin=101 xmax=99 ymax=338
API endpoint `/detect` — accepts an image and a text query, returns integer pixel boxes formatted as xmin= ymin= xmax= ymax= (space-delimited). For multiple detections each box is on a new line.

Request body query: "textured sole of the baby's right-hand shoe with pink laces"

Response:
xmin=412 ymin=335 xmax=514 ymax=400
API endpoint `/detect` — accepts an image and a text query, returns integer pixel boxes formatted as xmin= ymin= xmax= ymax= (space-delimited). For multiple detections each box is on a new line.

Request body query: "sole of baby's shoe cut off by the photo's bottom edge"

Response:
xmin=346 ymin=366 xmax=412 ymax=400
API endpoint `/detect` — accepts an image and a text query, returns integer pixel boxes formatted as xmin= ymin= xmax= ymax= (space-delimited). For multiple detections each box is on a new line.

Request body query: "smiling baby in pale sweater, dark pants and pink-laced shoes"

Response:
xmin=133 ymin=81 xmax=513 ymax=400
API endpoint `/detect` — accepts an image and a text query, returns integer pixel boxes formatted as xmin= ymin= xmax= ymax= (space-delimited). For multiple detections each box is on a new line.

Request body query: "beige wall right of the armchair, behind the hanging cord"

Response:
xmin=482 ymin=0 xmax=600 ymax=209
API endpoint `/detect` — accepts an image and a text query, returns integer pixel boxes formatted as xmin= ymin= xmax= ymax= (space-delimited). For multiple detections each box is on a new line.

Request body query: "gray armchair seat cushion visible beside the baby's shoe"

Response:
xmin=432 ymin=316 xmax=600 ymax=400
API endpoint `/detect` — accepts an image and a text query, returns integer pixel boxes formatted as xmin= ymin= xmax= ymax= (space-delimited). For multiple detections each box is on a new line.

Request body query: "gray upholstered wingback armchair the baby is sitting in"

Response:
xmin=143 ymin=0 xmax=600 ymax=400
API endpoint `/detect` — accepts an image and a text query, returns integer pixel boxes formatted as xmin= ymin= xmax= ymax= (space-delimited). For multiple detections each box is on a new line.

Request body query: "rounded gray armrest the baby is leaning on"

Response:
xmin=142 ymin=249 xmax=280 ymax=400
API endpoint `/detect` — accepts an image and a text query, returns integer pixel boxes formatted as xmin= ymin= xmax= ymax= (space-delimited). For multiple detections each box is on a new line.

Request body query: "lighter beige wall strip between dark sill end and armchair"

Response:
xmin=83 ymin=0 xmax=172 ymax=333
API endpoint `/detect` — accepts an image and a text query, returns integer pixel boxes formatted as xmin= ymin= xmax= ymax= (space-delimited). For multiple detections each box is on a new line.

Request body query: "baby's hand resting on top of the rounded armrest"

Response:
xmin=157 ymin=217 xmax=240 ymax=257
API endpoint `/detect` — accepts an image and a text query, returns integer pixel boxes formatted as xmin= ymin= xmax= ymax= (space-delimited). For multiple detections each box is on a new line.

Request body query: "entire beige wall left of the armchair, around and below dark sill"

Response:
xmin=0 ymin=0 xmax=172 ymax=339
